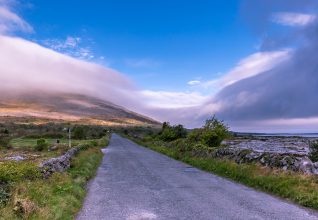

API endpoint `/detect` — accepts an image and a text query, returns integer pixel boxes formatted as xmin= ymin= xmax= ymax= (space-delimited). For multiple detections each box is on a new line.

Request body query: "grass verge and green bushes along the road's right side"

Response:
xmin=122 ymin=116 xmax=318 ymax=209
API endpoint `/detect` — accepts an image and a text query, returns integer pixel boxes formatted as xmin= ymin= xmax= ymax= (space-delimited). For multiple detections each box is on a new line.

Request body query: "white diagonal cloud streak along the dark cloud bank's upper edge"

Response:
xmin=202 ymin=49 xmax=292 ymax=88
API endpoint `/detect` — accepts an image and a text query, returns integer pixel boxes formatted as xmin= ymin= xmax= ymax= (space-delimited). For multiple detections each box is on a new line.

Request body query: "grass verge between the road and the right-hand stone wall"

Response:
xmin=126 ymin=137 xmax=318 ymax=209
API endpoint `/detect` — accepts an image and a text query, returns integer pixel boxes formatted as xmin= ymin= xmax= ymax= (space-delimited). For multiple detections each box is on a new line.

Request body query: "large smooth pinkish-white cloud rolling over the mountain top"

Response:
xmin=0 ymin=35 xmax=142 ymax=109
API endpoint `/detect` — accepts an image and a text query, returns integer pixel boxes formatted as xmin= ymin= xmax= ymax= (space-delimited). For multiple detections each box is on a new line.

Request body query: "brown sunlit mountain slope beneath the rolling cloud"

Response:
xmin=0 ymin=92 xmax=161 ymax=126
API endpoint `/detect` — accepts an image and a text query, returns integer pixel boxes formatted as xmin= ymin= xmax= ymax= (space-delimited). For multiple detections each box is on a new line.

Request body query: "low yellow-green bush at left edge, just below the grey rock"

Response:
xmin=0 ymin=161 xmax=40 ymax=183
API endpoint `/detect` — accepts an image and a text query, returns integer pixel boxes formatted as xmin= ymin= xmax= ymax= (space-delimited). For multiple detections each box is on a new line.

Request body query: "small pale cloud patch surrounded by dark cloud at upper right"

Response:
xmin=271 ymin=12 xmax=316 ymax=26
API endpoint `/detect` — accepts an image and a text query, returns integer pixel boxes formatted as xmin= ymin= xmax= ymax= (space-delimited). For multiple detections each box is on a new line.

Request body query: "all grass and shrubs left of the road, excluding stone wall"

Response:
xmin=0 ymin=126 xmax=110 ymax=220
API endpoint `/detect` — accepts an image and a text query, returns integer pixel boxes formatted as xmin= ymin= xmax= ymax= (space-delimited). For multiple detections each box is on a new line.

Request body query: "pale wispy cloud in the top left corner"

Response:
xmin=0 ymin=1 xmax=33 ymax=34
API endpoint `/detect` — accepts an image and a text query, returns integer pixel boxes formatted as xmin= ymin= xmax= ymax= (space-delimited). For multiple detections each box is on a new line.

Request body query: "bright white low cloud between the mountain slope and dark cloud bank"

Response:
xmin=140 ymin=90 xmax=207 ymax=108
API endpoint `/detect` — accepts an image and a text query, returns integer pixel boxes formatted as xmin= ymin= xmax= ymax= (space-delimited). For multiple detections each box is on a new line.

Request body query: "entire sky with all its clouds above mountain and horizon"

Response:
xmin=0 ymin=0 xmax=318 ymax=132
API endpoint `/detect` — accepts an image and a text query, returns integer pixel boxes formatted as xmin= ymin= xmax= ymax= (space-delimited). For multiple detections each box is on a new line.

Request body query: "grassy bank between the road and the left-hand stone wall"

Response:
xmin=0 ymin=135 xmax=110 ymax=220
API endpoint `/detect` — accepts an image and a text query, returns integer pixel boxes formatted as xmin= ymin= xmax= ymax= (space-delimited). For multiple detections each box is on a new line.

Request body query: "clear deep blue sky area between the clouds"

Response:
xmin=21 ymin=0 xmax=259 ymax=95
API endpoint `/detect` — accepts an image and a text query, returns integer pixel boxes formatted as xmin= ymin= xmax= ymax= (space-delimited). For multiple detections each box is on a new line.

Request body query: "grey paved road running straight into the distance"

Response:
xmin=76 ymin=134 xmax=318 ymax=220
